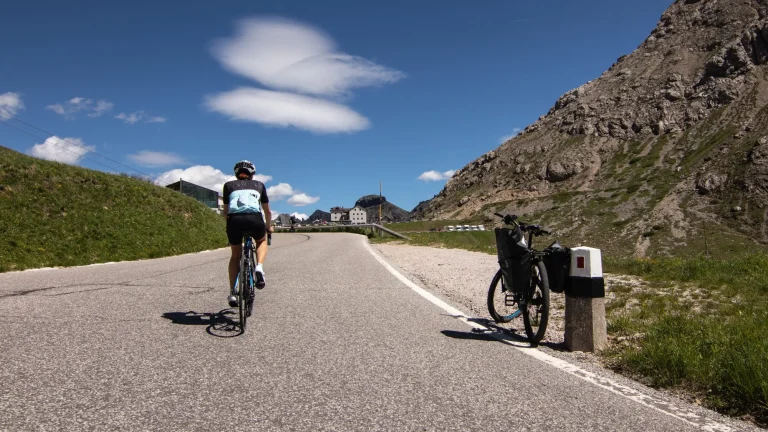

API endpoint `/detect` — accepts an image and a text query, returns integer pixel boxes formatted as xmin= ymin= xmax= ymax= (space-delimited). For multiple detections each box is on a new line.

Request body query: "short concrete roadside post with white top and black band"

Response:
xmin=565 ymin=247 xmax=608 ymax=352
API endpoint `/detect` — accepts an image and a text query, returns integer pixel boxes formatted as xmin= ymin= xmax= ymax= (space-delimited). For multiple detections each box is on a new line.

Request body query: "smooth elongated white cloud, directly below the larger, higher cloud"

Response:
xmin=206 ymin=88 xmax=370 ymax=133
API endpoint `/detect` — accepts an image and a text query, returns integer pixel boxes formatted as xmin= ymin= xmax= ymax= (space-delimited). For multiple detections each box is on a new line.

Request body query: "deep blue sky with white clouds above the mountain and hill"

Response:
xmin=0 ymin=0 xmax=671 ymax=218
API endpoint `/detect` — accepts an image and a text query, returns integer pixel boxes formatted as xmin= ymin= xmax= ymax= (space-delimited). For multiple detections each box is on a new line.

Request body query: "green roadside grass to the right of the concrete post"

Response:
xmin=604 ymin=253 xmax=768 ymax=424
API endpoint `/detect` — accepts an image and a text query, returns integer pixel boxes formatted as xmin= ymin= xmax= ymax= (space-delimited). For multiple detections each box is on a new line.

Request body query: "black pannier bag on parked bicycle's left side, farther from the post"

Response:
xmin=494 ymin=227 xmax=531 ymax=292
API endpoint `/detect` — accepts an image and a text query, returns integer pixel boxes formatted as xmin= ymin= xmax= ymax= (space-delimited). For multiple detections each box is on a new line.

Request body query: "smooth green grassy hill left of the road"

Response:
xmin=0 ymin=147 xmax=227 ymax=272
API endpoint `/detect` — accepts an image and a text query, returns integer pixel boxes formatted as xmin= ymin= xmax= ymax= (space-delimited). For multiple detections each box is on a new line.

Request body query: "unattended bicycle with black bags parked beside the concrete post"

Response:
xmin=488 ymin=213 xmax=565 ymax=345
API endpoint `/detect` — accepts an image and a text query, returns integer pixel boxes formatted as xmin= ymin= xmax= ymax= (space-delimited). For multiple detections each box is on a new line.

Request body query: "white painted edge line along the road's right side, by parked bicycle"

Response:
xmin=362 ymin=237 xmax=734 ymax=432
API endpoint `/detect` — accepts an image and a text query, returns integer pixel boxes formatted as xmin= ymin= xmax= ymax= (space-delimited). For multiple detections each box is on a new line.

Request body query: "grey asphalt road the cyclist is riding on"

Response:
xmin=0 ymin=233 xmax=756 ymax=432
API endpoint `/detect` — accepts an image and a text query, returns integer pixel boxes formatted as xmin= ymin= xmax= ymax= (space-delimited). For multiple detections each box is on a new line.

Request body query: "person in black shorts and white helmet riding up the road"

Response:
xmin=223 ymin=160 xmax=273 ymax=307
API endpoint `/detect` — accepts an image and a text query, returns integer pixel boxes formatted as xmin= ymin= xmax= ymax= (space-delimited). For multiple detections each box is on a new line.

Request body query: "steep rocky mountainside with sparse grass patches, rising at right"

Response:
xmin=414 ymin=0 xmax=768 ymax=256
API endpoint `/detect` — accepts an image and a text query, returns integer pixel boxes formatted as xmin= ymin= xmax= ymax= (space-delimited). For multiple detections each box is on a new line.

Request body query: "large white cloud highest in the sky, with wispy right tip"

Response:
xmin=211 ymin=17 xmax=405 ymax=95
